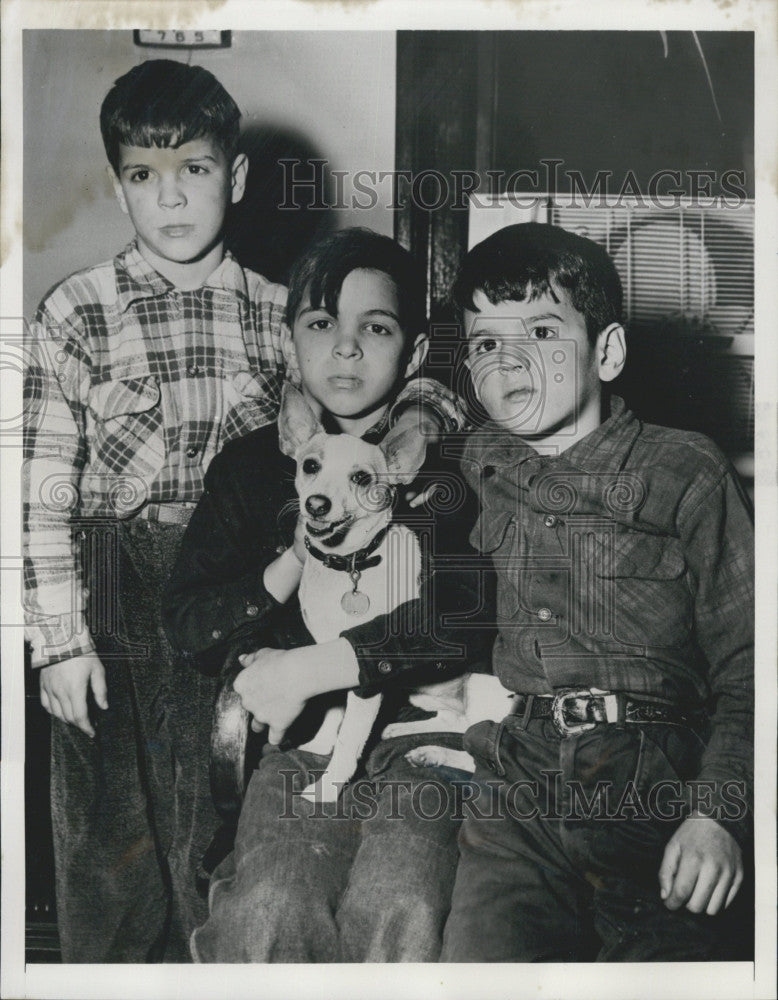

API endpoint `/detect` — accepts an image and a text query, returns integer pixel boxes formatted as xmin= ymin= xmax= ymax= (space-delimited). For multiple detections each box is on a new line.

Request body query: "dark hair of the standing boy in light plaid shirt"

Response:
xmin=100 ymin=59 xmax=240 ymax=172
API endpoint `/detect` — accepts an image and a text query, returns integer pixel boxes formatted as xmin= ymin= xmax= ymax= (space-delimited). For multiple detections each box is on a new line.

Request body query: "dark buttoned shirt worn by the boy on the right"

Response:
xmin=462 ymin=397 xmax=754 ymax=820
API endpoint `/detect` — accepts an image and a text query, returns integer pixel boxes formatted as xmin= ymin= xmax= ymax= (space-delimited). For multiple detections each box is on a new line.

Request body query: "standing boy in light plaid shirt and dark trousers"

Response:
xmin=24 ymin=60 xmax=459 ymax=962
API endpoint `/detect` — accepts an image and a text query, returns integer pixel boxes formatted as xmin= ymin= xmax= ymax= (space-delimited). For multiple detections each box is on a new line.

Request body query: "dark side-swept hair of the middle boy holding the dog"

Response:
xmin=286 ymin=227 xmax=427 ymax=348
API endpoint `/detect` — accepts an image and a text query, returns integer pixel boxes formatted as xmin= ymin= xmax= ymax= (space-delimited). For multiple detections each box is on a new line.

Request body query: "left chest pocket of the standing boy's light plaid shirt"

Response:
xmin=87 ymin=374 xmax=165 ymax=483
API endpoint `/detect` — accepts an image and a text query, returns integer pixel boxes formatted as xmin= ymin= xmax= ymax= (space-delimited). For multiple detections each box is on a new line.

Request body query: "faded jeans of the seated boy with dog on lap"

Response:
xmin=191 ymin=734 xmax=461 ymax=962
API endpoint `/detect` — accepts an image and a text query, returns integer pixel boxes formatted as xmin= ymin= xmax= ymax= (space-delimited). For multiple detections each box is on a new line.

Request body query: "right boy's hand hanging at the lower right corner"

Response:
xmin=659 ymin=816 xmax=743 ymax=917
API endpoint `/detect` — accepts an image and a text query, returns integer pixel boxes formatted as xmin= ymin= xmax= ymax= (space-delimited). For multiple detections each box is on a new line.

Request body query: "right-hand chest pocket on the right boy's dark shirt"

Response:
xmin=593 ymin=529 xmax=694 ymax=647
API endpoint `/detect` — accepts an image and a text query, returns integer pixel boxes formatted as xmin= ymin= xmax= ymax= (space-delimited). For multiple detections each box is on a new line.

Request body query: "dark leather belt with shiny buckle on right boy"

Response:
xmin=510 ymin=688 xmax=703 ymax=739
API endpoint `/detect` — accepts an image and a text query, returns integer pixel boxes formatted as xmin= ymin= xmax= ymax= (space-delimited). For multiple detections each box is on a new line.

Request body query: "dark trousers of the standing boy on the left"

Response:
xmin=52 ymin=520 xmax=219 ymax=962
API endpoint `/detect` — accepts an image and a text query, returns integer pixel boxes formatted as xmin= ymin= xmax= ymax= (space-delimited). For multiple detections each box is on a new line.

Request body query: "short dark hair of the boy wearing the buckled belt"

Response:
xmin=451 ymin=222 xmax=622 ymax=343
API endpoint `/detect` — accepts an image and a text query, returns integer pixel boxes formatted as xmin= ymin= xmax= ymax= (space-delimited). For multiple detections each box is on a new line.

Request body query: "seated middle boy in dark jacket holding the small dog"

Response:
xmin=166 ymin=230 xmax=491 ymax=962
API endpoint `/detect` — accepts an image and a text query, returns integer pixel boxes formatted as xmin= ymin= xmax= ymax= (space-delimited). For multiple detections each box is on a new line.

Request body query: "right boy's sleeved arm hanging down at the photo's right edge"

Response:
xmin=659 ymin=471 xmax=754 ymax=914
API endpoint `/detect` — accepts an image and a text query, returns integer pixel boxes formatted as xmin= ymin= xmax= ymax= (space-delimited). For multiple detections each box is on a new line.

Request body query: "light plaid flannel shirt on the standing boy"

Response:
xmin=24 ymin=242 xmax=464 ymax=667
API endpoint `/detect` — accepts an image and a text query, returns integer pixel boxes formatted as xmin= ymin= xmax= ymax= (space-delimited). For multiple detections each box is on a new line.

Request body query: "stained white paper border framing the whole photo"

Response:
xmin=0 ymin=0 xmax=778 ymax=1000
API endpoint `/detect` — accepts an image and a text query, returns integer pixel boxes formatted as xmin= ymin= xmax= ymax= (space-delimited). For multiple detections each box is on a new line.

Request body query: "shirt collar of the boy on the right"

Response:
xmin=465 ymin=396 xmax=640 ymax=474
